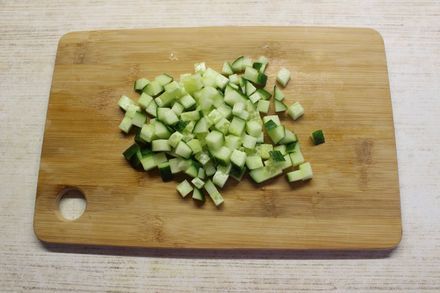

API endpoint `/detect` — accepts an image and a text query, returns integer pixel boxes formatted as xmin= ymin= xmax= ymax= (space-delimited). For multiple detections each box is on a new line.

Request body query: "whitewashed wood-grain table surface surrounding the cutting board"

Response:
xmin=0 ymin=0 xmax=440 ymax=292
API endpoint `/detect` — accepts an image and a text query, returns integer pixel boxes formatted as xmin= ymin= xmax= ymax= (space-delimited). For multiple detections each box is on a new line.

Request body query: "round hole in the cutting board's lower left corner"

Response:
xmin=58 ymin=187 xmax=87 ymax=221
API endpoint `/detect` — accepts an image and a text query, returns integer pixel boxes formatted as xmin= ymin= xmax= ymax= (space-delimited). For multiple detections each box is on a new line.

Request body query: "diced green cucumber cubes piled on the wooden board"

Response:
xmin=119 ymin=56 xmax=325 ymax=206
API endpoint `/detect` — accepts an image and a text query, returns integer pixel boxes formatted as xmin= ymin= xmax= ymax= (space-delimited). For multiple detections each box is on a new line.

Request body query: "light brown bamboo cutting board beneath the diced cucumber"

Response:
xmin=34 ymin=27 xmax=401 ymax=249
